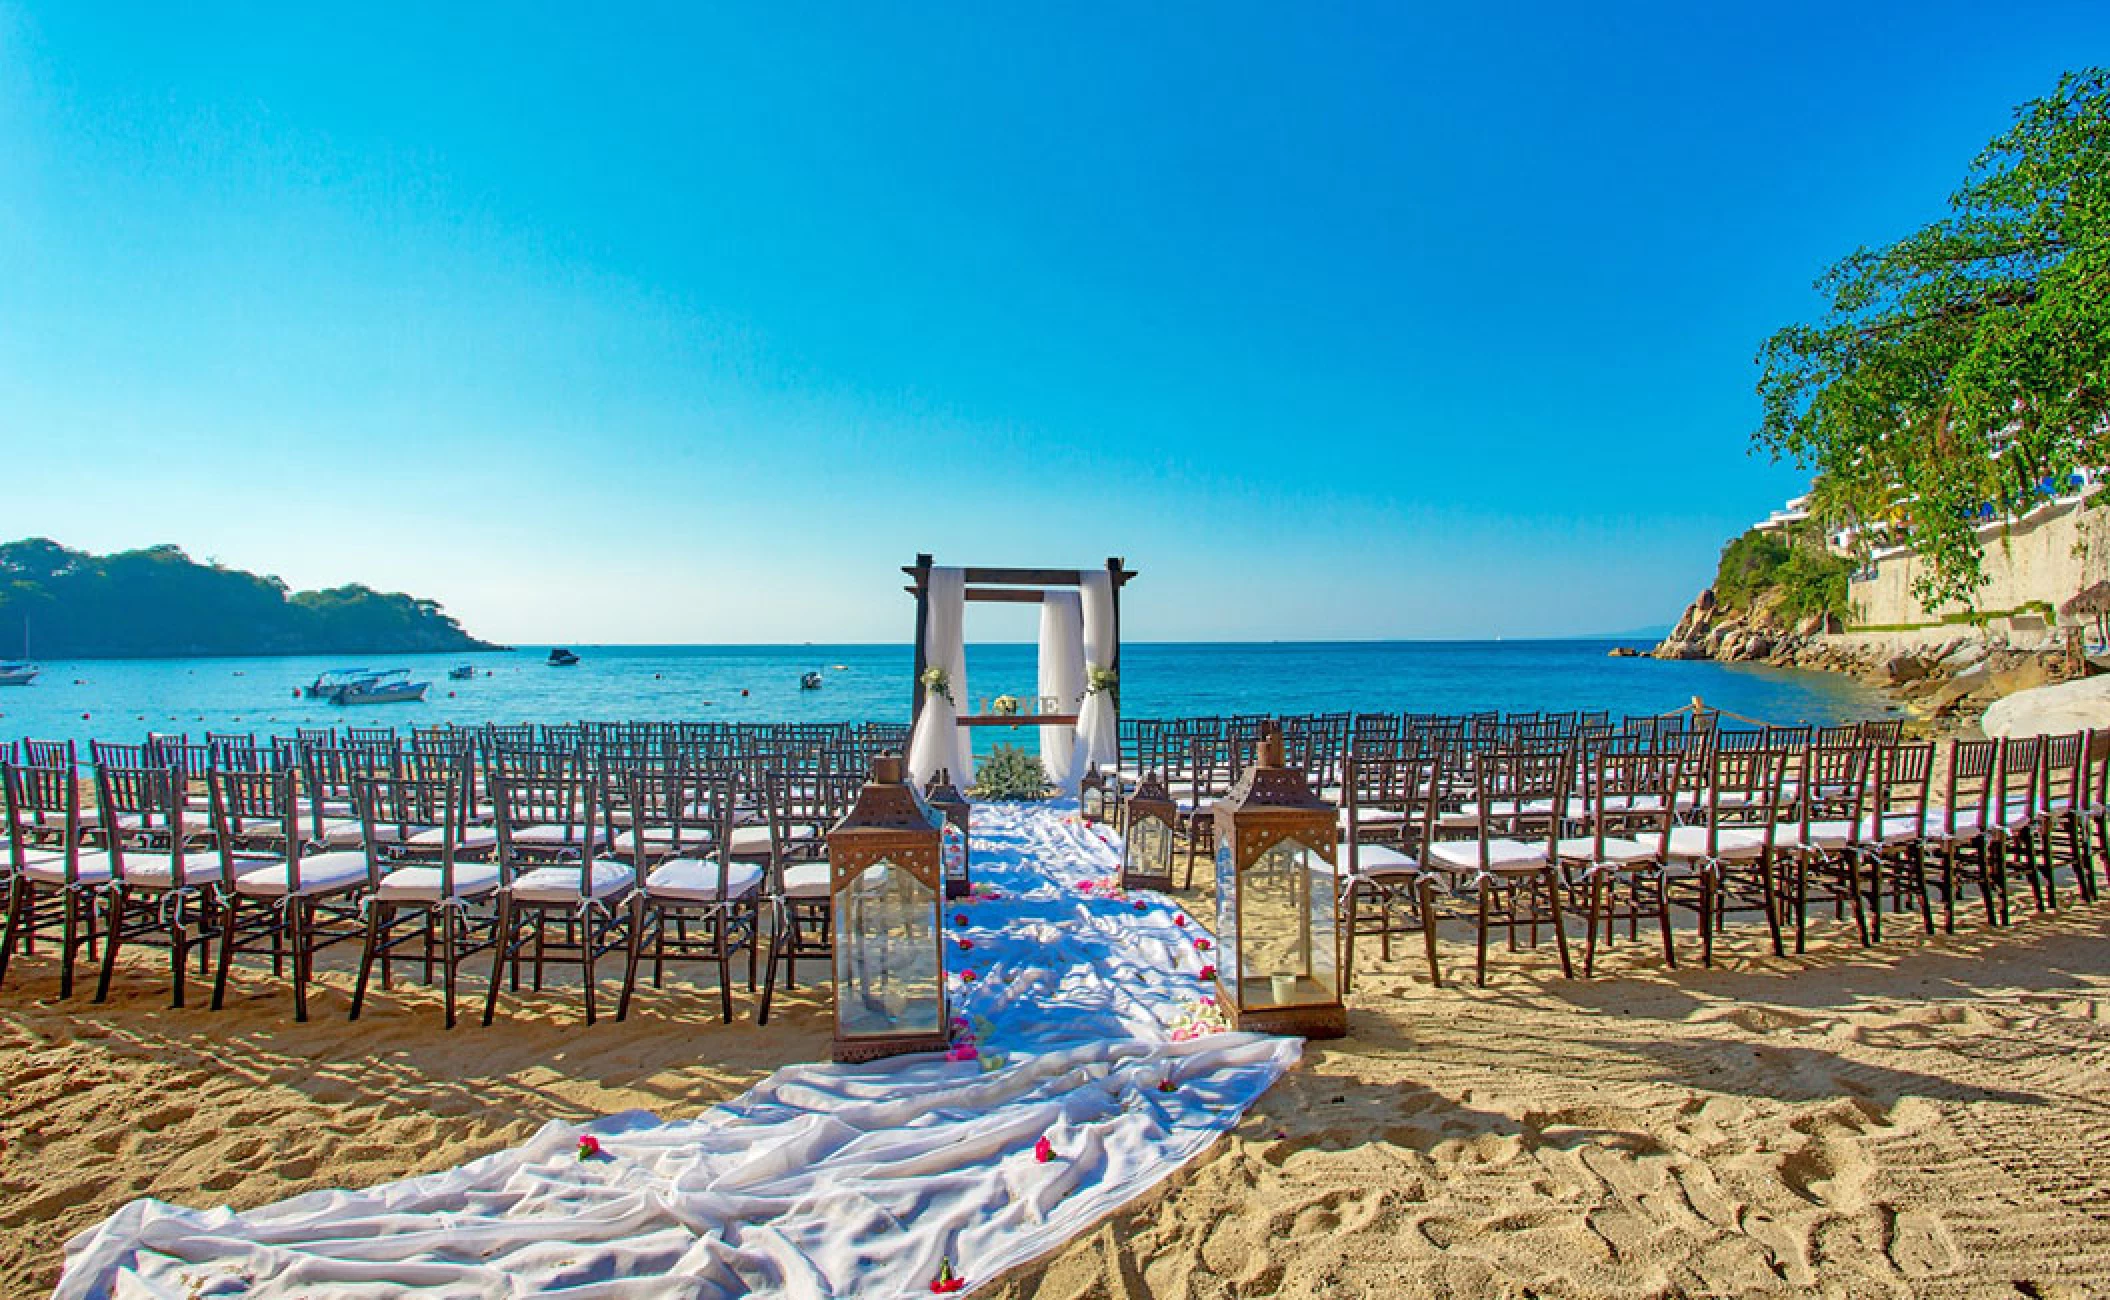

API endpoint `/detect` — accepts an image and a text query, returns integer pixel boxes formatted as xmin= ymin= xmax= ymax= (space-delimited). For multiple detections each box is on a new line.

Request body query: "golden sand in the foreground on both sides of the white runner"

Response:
xmin=0 ymin=877 xmax=2110 ymax=1300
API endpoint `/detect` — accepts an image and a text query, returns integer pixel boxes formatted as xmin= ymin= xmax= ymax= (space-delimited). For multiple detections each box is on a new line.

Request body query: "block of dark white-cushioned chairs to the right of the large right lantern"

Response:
xmin=1340 ymin=732 xmax=2110 ymax=981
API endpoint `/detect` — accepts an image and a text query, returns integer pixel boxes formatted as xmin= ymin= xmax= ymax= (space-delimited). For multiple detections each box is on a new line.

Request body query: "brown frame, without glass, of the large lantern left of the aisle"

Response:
xmin=827 ymin=753 xmax=952 ymax=1064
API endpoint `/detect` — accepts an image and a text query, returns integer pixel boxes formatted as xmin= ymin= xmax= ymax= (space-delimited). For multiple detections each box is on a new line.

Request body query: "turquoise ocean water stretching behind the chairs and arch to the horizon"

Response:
xmin=0 ymin=642 xmax=1884 ymax=749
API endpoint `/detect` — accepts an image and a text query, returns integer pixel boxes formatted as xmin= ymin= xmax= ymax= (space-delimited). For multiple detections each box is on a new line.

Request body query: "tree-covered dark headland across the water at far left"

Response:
xmin=0 ymin=538 xmax=497 ymax=658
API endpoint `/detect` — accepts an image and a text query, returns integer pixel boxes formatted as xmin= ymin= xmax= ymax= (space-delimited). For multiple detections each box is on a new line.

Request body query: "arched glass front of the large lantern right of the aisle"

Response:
xmin=1226 ymin=840 xmax=1340 ymax=1007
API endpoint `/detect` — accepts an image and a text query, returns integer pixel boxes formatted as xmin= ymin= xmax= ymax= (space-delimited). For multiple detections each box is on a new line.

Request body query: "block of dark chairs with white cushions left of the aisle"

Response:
xmin=0 ymin=730 xmax=899 ymax=1026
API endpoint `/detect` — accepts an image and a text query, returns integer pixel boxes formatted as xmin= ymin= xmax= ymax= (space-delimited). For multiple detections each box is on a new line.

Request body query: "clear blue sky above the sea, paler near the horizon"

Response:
xmin=0 ymin=0 xmax=2110 ymax=642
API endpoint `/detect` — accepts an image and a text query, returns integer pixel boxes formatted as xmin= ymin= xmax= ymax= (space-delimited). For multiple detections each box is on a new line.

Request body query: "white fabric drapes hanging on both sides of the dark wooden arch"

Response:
xmin=909 ymin=566 xmax=1120 ymax=796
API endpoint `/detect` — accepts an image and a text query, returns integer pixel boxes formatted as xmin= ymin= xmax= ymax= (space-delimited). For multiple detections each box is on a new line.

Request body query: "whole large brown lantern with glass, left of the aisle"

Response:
xmin=827 ymin=753 xmax=952 ymax=1062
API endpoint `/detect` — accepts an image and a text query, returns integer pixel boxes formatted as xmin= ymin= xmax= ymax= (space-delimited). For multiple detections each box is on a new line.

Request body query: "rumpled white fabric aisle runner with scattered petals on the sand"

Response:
xmin=57 ymin=804 xmax=1300 ymax=1300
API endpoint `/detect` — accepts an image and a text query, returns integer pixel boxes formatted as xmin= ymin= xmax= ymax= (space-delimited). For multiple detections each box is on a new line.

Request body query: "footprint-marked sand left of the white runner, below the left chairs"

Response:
xmin=0 ymin=948 xmax=829 ymax=1298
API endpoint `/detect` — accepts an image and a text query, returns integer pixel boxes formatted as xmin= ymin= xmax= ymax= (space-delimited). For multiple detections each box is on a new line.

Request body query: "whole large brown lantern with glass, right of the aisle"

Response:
xmin=1213 ymin=726 xmax=1348 ymax=1038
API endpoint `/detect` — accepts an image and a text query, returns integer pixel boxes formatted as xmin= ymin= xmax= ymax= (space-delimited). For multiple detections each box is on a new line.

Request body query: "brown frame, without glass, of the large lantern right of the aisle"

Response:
xmin=1211 ymin=726 xmax=1348 ymax=1038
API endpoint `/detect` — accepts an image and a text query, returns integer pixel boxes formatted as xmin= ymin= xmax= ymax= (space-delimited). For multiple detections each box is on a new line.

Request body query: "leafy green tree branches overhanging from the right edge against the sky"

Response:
xmin=1753 ymin=68 xmax=2110 ymax=606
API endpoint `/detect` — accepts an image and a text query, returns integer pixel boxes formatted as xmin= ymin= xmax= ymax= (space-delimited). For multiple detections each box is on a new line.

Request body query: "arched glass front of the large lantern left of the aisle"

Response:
xmin=836 ymin=859 xmax=945 ymax=1038
